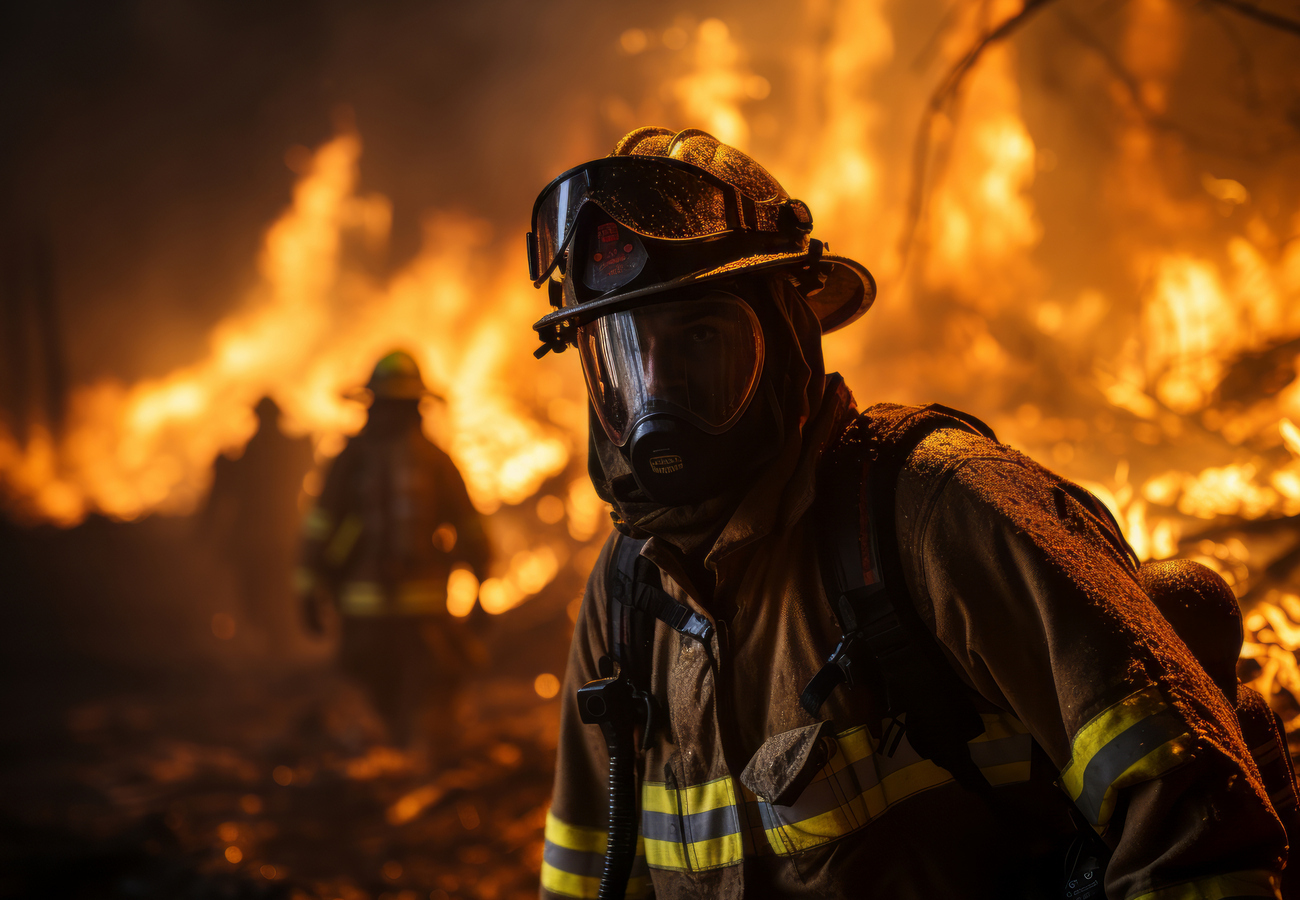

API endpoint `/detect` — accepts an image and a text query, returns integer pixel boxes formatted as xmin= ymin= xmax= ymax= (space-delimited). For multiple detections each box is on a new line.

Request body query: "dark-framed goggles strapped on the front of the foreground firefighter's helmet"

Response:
xmin=528 ymin=156 xmax=788 ymax=287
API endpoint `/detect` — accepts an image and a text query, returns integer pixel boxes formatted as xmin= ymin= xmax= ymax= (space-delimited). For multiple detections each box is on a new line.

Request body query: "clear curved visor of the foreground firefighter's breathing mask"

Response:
xmin=577 ymin=290 xmax=763 ymax=446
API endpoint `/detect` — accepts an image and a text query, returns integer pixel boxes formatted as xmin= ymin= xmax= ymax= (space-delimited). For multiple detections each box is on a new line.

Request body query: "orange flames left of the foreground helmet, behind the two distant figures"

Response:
xmin=0 ymin=133 xmax=573 ymax=524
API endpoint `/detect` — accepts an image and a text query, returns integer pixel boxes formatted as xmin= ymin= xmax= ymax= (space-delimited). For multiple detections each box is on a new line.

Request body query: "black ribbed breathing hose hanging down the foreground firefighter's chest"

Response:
xmin=577 ymin=676 xmax=637 ymax=900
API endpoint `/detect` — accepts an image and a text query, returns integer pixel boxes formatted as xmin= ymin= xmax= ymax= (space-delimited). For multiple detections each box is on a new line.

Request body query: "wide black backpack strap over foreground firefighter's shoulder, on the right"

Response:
xmin=800 ymin=410 xmax=992 ymax=795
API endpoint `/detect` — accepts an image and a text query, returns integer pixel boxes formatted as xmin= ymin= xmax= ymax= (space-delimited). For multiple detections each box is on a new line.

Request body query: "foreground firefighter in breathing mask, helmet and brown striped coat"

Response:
xmin=528 ymin=127 xmax=1290 ymax=900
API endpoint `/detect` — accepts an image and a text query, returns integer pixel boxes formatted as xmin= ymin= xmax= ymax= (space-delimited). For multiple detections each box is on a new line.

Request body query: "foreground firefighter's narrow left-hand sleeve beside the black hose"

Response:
xmin=541 ymin=533 xmax=650 ymax=900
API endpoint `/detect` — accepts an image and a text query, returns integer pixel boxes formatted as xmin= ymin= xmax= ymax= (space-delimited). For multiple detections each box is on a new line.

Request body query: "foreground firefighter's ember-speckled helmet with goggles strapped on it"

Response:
xmin=528 ymin=127 xmax=876 ymax=355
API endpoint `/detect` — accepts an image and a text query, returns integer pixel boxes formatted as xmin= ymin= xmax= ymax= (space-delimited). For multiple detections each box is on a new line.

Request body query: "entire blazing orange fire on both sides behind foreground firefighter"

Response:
xmin=0 ymin=7 xmax=1300 ymax=710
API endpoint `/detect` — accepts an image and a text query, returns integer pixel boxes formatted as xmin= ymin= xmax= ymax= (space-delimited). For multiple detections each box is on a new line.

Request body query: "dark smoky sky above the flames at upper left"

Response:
xmin=0 ymin=0 xmax=759 ymax=382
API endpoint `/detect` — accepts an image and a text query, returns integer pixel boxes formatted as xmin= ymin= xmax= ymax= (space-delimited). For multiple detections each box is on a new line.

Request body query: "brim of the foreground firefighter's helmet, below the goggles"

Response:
xmin=533 ymin=252 xmax=876 ymax=339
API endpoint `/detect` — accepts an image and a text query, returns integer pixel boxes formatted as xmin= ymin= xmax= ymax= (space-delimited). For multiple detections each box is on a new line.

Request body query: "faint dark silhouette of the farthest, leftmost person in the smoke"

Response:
xmin=200 ymin=397 xmax=312 ymax=653
